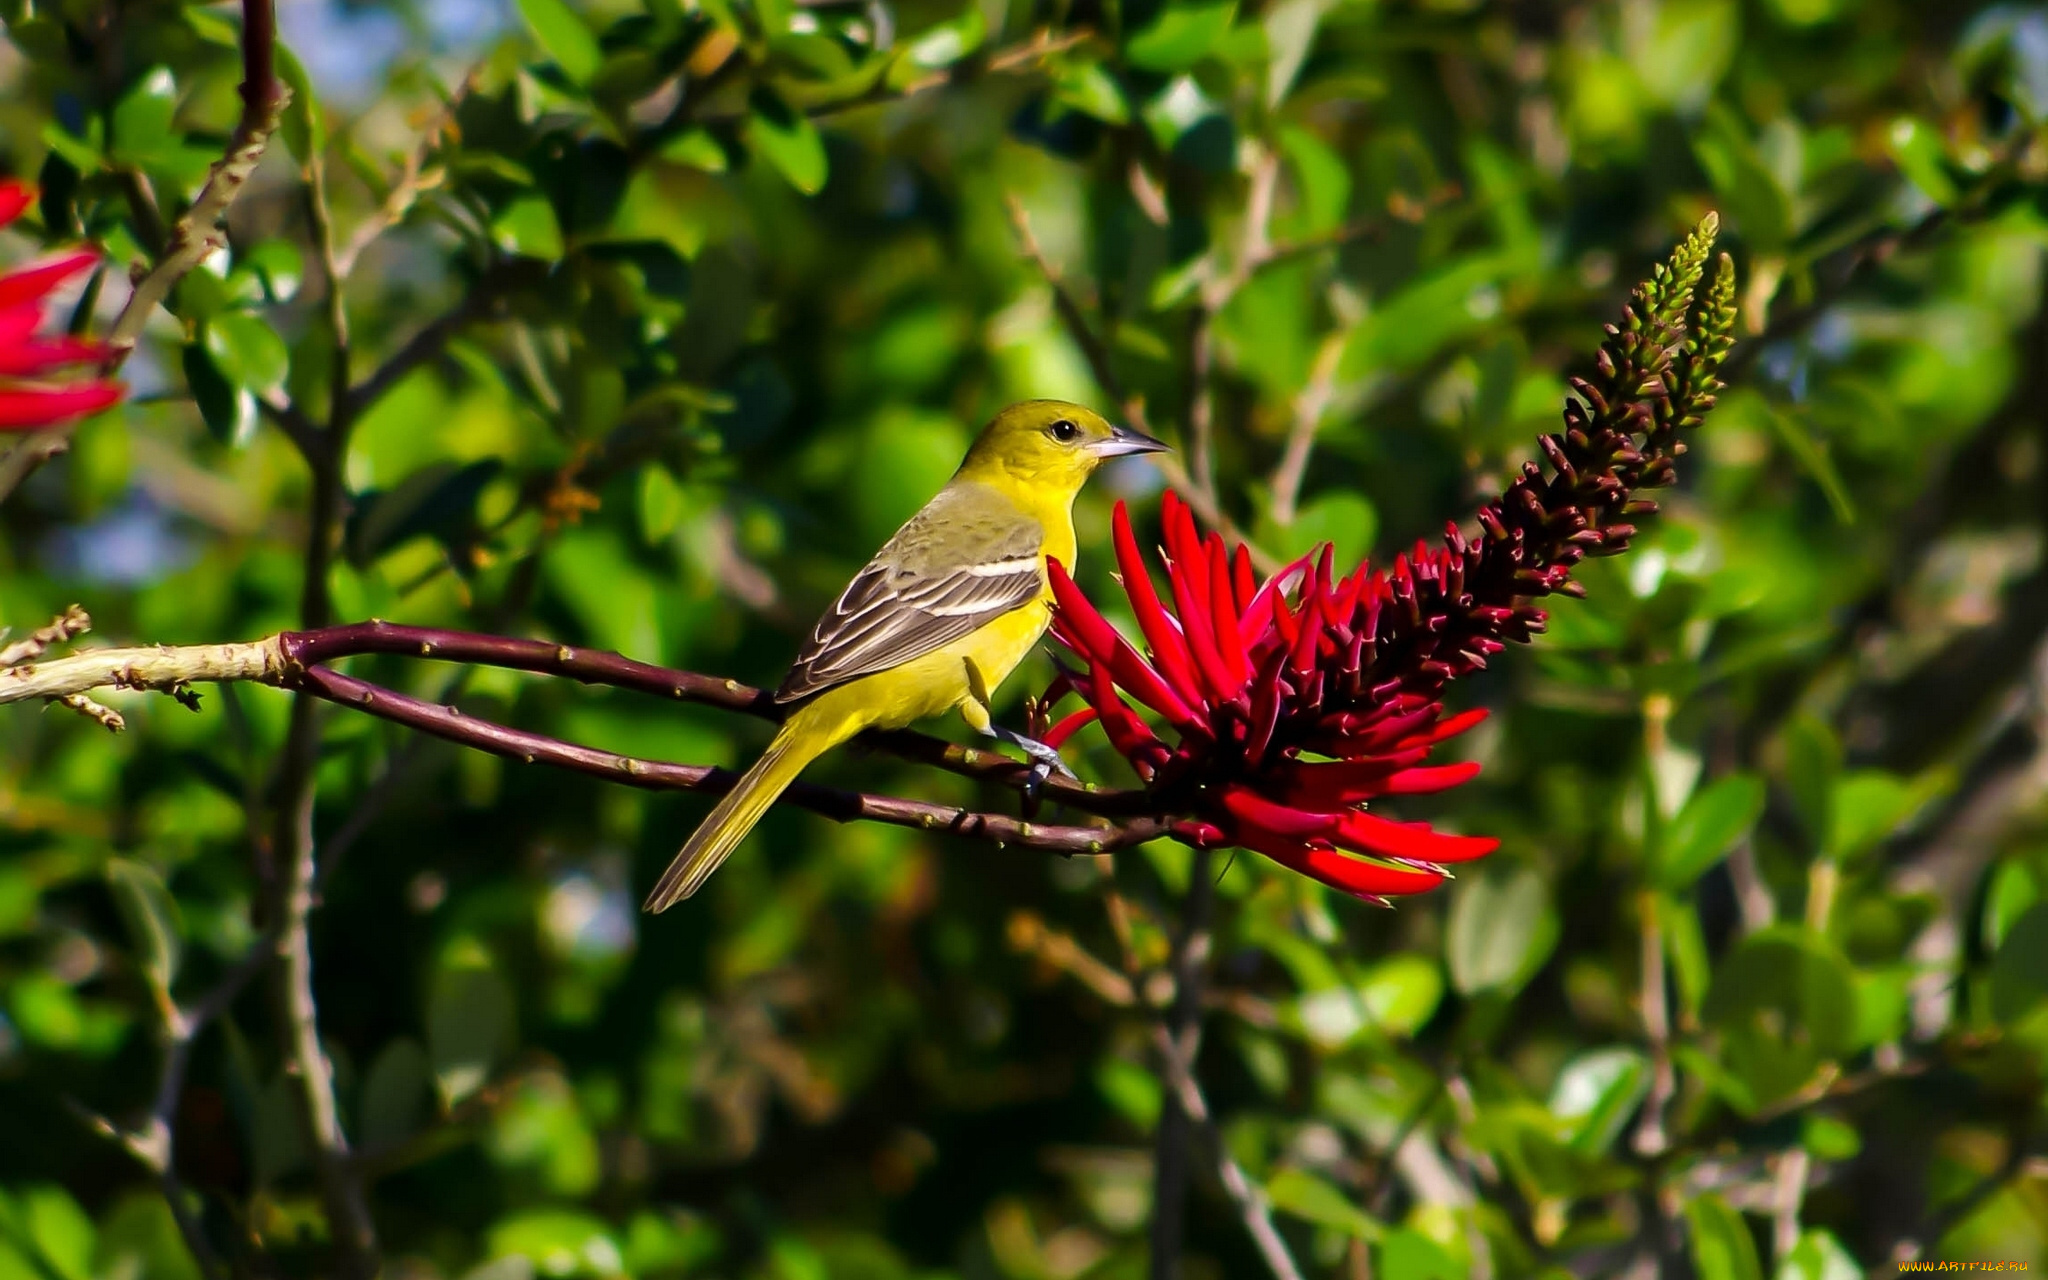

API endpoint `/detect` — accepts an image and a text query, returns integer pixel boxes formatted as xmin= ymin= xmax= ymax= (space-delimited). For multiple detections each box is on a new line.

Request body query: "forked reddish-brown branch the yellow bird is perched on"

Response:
xmin=0 ymin=621 xmax=1167 ymax=854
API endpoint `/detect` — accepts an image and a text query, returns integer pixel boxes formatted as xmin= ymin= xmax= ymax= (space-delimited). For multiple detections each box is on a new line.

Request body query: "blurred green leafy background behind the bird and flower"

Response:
xmin=0 ymin=0 xmax=2048 ymax=1280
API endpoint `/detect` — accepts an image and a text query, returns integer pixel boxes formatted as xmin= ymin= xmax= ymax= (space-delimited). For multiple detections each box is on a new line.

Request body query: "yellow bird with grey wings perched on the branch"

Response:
xmin=645 ymin=399 xmax=1165 ymax=911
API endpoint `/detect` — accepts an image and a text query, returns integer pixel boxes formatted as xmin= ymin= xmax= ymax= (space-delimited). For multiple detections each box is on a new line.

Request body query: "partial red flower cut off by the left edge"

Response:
xmin=0 ymin=182 xmax=125 ymax=432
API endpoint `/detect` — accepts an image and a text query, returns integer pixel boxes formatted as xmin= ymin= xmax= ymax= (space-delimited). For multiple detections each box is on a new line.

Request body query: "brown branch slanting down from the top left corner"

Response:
xmin=0 ymin=0 xmax=291 ymax=502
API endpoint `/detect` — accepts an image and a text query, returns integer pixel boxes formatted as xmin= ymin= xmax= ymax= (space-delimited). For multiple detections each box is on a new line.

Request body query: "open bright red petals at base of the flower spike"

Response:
xmin=1044 ymin=494 xmax=1499 ymax=899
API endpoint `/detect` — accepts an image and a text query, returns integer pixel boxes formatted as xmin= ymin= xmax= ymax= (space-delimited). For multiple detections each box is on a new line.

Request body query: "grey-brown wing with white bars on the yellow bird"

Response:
xmin=776 ymin=485 xmax=1044 ymax=702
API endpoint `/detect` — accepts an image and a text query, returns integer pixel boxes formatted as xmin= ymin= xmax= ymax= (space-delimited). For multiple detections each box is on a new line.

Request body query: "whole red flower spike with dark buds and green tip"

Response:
xmin=1044 ymin=217 xmax=1735 ymax=901
